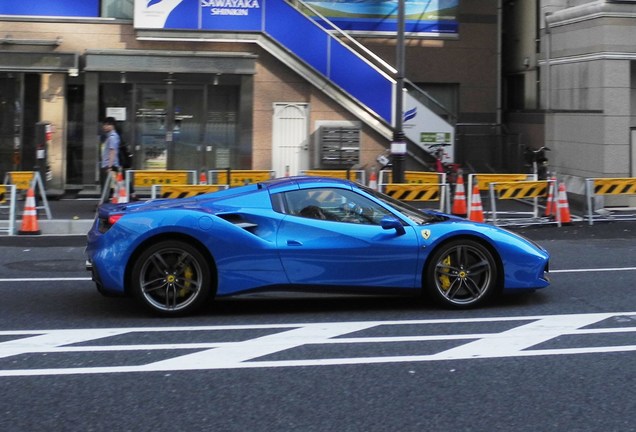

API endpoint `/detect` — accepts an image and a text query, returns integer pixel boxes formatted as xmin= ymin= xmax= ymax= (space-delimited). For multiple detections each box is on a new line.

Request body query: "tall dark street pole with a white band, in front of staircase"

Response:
xmin=391 ymin=0 xmax=406 ymax=183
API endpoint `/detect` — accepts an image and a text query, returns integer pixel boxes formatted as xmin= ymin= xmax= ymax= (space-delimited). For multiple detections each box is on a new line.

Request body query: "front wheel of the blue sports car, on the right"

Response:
xmin=425 ymin=239 xmax=498 ymax=309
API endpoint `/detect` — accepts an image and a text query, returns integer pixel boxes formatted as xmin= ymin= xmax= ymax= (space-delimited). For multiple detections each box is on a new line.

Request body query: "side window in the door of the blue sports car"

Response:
xmin=284 ymin=188 xmax=390 ymax=225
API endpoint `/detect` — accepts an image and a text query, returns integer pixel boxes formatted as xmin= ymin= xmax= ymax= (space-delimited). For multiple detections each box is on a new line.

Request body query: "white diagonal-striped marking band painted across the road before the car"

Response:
xmin=0 ymin=312 xmax=636 ymax=377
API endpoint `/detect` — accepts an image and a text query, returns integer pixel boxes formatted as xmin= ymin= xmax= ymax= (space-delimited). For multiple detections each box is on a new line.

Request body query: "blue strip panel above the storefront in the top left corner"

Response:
xmin=0 ymin=0 xmax=100 ymax=17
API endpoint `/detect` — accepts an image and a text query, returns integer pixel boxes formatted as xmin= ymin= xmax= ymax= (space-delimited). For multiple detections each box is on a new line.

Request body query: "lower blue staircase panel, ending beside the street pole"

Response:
xmin=331 ymin=41 xmax=393 ymax=123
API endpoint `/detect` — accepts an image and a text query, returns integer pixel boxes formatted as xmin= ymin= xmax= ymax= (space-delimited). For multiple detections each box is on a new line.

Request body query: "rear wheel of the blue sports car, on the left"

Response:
xmin=131 ymin=240 xmax=212 ymax=316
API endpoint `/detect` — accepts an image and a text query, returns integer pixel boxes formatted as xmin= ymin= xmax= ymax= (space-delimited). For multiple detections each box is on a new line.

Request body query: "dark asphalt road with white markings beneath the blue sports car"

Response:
xmin=0 ymin=222 xmax=636 ymax=432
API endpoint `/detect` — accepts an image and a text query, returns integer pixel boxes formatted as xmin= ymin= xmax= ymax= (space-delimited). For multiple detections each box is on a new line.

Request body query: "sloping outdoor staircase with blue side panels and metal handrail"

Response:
xmin=137 ymin=0 xmax=454 ymax=166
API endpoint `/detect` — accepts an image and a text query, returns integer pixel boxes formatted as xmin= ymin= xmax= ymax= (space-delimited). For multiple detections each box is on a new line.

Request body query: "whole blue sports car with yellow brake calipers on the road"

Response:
xmin=86 ymin=177 xmax=549 ymax=316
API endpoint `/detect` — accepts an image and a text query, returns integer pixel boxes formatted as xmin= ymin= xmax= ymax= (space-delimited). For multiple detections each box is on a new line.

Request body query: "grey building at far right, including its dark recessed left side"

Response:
xmin=503 ymin=0 xmax=636 ymax=205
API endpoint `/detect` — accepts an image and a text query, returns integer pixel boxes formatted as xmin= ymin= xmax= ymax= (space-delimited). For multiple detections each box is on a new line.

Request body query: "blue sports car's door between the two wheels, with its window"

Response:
xmin=277 ymin=190 xmax=420 ymax=288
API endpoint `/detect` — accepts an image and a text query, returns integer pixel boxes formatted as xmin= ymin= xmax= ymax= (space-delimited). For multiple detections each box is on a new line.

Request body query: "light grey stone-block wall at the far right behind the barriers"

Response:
xmin=541 ymin=2 xmax=636 ymax=201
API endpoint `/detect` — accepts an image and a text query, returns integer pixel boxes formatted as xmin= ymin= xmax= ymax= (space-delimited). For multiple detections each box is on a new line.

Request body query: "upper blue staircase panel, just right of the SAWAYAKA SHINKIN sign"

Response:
xmin=265 ymin=0 xmax=329 ymax=75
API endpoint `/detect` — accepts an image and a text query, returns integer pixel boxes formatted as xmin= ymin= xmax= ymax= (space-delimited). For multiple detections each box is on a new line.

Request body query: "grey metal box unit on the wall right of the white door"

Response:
xmin=316 ymin=126 xmax=360 ymax=169
